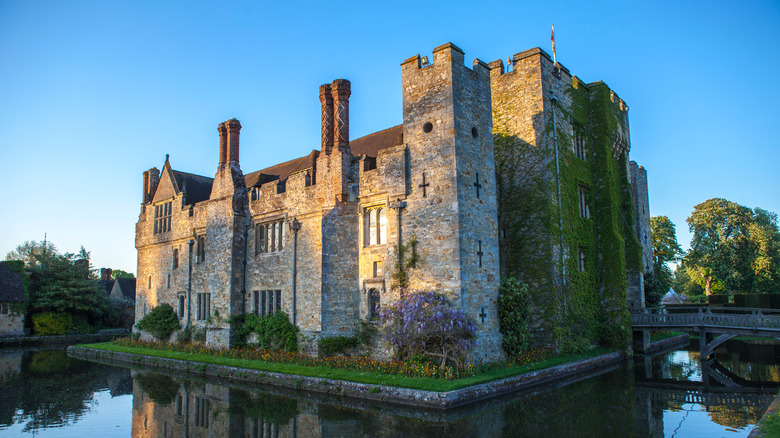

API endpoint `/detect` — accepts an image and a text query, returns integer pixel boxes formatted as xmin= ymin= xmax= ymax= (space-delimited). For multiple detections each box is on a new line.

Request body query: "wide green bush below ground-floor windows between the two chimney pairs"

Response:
xmin=231 ymin=312 xmax=299 ymax=352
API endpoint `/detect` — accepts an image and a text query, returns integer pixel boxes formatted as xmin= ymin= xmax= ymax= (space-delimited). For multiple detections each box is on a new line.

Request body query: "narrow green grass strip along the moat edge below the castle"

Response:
xmin=79 ymin=342 xmax=614 ymax=392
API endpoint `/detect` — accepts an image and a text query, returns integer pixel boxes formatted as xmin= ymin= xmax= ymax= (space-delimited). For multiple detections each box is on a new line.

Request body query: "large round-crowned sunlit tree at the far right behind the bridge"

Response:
xmin=686 ymin=198 xmax=780 ymax=295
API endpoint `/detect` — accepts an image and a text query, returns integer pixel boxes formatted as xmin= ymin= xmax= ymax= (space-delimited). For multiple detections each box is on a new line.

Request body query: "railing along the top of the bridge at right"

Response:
xmin=631 ymin=307 xmax=780 ymax=330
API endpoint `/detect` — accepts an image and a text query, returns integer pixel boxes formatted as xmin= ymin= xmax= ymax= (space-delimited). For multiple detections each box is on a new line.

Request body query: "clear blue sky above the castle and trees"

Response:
xmin=0 ymin=0 xmax=780 ymax=272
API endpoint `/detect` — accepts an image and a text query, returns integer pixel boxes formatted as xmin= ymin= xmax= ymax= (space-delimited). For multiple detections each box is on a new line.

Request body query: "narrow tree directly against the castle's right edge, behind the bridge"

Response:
xmin=645 ymin=216 xmax=683 ymax=307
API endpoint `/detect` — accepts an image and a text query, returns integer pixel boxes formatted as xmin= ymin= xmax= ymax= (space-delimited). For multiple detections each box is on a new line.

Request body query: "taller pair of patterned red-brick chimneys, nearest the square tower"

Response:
xmin=320 ymin=79 xmax=351 ymax=154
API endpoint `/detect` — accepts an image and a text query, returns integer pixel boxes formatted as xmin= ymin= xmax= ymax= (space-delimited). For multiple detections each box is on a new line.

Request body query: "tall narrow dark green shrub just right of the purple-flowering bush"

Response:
xmin=498 ymin=278 xmax=531 ymax=357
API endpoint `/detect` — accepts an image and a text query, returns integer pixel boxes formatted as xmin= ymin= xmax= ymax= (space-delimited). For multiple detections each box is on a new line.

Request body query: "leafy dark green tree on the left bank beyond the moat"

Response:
xmin=30 ymin=253 xmax=108 ymax=323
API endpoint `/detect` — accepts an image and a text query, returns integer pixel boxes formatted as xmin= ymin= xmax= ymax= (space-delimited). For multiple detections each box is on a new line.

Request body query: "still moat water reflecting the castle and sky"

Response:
xmin=0 ymin=341 xmax=780 ymax=438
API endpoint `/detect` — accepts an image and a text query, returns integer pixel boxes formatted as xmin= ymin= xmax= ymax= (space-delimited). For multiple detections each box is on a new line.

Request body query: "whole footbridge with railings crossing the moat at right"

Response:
xmin=631 ymin=307 xmax=780 ymax=360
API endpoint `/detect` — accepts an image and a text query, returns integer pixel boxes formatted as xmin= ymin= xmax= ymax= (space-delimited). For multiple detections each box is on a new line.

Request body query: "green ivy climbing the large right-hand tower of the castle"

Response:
xmin=493 ymin=79 xmax=642 ymax=352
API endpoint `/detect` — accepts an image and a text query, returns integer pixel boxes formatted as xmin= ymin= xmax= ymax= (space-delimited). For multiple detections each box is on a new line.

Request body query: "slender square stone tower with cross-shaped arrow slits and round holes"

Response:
xmin=402 ymin=43 xmax=502 ymax=360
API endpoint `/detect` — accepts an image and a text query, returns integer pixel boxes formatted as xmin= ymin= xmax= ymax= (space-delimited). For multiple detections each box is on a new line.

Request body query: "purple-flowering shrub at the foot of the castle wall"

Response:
xmin=380 ymin=292 xmax=477 ymax=368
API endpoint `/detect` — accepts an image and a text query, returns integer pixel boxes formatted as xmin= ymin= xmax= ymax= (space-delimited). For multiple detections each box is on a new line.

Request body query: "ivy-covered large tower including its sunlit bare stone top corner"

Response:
xmin=490 ymin=49 xmax=642 ymax=351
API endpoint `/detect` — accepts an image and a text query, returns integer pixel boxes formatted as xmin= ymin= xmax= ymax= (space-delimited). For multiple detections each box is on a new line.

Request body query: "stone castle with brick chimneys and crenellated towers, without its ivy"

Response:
xmin=136 ymin=43 xmax=649 ymax=360
